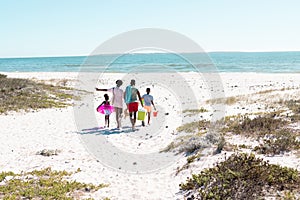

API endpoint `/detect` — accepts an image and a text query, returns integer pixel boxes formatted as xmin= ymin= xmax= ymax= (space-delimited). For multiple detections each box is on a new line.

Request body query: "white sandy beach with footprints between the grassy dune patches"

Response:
xmin=0 ymin=72 xmax=300 ymax=200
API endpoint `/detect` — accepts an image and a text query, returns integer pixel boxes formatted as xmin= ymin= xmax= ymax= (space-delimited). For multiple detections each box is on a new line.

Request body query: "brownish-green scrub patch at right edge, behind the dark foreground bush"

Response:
xmin=222 ymin=113 xmax=300 ymax=155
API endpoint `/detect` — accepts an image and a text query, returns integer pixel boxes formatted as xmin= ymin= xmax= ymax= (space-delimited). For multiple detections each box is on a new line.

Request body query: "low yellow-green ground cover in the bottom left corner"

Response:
xmin=0 ymin=168 xmax=108 ymax=200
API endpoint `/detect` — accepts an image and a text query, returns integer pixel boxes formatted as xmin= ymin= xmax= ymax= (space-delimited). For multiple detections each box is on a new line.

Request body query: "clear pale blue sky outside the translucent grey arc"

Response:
xmin=0 ymin=0 xmax=300 ymax=58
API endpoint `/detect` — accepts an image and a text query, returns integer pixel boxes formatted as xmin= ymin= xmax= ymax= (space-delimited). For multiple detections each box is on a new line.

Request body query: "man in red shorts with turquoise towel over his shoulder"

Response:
xmin=124 ymin=80 xmax=144 ymax=131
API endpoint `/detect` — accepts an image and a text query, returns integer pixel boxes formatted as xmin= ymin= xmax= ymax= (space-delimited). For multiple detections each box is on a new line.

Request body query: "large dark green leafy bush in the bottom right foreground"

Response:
xmin=180 ymin=154 xmax=300 ymax=200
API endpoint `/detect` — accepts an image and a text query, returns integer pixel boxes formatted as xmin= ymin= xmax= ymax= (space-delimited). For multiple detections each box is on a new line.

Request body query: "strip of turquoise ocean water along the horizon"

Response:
xmin=0 ymin=52 xmax=300 ymax=73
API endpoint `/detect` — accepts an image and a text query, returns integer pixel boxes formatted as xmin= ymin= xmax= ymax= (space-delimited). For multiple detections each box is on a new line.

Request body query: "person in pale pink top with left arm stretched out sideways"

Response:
xmin=96 ymin=80 xmax=124 ymax=129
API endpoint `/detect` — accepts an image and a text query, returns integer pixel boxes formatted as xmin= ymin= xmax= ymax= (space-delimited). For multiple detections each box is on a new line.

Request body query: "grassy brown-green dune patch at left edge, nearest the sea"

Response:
xmin=0 ymin=74 xmax=77 ymax=114
